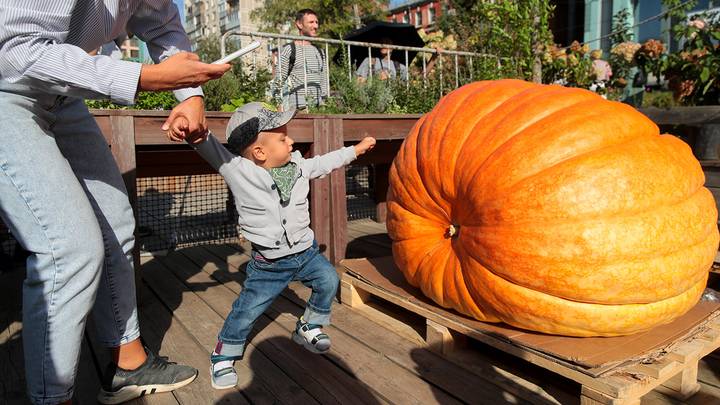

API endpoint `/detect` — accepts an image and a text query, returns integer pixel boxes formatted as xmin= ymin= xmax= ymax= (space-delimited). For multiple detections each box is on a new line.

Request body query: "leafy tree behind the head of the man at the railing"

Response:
xmin=251 ymin=0 xmax=383 ymax=38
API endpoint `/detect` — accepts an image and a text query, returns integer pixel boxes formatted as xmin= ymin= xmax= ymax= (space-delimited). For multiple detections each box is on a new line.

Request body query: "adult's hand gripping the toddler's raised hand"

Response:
xmin=162 ymin=96 xmax=207 ymax=143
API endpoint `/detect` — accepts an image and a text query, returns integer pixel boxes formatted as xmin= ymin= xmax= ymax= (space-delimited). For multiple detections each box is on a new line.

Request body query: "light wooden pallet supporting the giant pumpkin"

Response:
xmin=338 ymin=258 xmax=720 ymax=405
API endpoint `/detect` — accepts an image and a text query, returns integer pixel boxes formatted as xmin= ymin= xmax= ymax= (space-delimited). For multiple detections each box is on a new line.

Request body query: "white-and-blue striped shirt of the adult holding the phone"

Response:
xmin=0 ymin=0 xmax=202 ymax=104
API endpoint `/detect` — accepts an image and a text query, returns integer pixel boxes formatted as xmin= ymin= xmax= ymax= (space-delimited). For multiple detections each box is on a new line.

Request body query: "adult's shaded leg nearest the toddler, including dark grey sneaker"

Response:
xmin=48 ymin=99 xmax=197 ymax=404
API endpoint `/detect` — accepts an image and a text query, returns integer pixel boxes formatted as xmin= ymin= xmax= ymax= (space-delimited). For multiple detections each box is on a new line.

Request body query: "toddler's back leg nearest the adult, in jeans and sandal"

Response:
xmin=210 ymin=251 xmax=298 ymax=389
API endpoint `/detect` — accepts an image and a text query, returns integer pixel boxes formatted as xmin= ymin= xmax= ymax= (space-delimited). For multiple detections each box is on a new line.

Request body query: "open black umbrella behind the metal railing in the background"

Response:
xmin=333 ymin=21 xmax=425 ymax=67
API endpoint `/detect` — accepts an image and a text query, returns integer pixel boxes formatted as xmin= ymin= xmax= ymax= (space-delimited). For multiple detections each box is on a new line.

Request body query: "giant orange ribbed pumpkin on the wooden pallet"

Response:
xmin=387 ymin=80 xmax=718 ymax=336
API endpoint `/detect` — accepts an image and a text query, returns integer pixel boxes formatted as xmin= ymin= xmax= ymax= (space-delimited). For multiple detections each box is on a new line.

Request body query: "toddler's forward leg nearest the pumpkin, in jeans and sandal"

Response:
xmin=292 ymin=242 xmax=339 ymax=353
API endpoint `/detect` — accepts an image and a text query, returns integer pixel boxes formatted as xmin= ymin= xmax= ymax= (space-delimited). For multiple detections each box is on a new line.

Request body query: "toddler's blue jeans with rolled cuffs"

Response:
xmin=216 ymin=242 xmax=339 ymax=358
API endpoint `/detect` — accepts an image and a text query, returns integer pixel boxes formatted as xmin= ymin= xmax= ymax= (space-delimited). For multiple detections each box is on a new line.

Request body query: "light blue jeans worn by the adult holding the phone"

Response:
xmin=0 ymin=81 xmax=140 ymax=404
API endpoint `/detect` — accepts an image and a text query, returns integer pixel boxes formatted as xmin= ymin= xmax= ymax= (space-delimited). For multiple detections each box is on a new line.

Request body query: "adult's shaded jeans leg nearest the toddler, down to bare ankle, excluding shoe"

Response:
xmin=53 ymin=99 xmax=146 ymax=369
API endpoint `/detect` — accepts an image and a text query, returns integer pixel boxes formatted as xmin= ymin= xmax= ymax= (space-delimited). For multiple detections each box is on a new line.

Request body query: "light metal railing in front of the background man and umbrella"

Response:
xmin=220 ymin=30 xmax=503 ymax=94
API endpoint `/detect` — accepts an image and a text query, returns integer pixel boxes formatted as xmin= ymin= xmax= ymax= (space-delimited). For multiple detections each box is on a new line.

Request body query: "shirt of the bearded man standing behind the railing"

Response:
xmin=277 ymin=44 xmax=328 ymax=110
